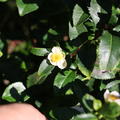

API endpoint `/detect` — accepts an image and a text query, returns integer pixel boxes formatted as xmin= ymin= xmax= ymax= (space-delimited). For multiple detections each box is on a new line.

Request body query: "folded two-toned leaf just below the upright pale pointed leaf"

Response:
xmin=69 ymin=23 xmax=87 ymax=40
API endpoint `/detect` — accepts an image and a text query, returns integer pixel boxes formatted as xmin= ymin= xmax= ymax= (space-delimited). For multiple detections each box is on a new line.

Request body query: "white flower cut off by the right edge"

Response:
xmin=104 ymin=90 xmax=120 ymax=105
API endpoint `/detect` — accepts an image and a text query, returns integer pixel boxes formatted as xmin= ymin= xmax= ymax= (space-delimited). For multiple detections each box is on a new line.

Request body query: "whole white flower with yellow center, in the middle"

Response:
xmin=48 ymin=46 xmax=67 ymax=69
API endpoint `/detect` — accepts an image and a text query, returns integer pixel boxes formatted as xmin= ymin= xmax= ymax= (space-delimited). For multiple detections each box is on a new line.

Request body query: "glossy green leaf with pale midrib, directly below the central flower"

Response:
xmin=54 ymin=70 xmax=76 ymax=89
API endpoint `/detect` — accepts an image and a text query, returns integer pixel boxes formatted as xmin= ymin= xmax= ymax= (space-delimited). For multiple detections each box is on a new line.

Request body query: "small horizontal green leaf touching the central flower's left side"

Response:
xmin=31 ymin=47 xmax=49 ymax=56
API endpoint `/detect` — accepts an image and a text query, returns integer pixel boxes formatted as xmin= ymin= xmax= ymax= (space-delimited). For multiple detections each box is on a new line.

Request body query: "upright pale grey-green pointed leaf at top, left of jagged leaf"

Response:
xmin=72 ymin=4 xmax=84 ymax=26
